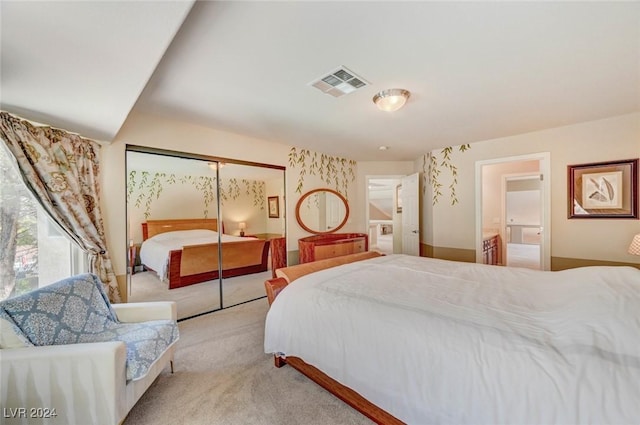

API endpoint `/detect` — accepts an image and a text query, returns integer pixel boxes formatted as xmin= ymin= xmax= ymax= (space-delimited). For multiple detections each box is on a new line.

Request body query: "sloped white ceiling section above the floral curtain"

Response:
xmin=0 ymin=1 xmax=193 ymax=142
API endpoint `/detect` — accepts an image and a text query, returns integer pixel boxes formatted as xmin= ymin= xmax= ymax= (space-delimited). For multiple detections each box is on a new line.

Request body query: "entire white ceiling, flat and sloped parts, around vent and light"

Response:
xmin=0 ymin=0 xmax=640 ymax=160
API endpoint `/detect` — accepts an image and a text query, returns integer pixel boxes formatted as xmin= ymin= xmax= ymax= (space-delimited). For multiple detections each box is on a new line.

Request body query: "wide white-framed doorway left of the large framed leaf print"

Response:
xmin=476 ymin=152 xmax=551 ymax=270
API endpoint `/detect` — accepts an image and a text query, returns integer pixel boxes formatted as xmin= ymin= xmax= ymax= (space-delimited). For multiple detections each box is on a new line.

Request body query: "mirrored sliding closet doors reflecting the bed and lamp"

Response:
xmin=127 ymin=147 xmax=284 ymax=319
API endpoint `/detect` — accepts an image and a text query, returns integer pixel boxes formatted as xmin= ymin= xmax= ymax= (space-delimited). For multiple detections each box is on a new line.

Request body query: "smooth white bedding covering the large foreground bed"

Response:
xmin=265 ymin=255 xmax=640 ymax=424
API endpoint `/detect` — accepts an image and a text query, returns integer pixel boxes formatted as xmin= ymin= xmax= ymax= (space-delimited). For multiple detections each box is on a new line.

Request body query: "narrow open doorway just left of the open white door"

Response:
xmin=367 ymin=176 xmax=402 ymax=254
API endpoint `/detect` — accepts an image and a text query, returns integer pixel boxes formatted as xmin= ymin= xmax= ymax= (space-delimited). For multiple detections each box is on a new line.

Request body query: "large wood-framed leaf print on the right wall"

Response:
xmin=567 ymin=158 xmax=638 ymax=219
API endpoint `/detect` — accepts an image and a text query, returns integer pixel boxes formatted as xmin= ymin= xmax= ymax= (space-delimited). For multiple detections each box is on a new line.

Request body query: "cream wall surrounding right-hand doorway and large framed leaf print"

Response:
xmin=416 ymin=113 xmax=640 ymax=263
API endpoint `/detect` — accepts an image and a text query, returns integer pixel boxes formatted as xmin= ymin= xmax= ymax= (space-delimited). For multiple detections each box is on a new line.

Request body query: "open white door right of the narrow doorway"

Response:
xmin=398 ymin=173 xmax=420 ymax=256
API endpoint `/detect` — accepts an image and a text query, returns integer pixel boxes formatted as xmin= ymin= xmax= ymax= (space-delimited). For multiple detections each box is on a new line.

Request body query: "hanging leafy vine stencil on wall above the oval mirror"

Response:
xmin=289 ymin=147 xmax=356 ymax=197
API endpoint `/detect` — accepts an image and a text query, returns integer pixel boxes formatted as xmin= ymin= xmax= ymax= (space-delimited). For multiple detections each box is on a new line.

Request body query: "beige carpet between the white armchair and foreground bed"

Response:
xmin=124 ymin=299 xmax=372 ymax=425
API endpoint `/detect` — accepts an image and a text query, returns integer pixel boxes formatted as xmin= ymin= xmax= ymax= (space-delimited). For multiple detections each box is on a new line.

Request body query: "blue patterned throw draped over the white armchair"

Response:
xmin=0 ymin=273 xmax=178 ymax=380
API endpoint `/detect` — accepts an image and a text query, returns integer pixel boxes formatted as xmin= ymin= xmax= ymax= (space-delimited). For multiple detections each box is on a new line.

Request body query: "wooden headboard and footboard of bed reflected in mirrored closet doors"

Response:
xmin=142 ymin=219 xmax=269 ymax=289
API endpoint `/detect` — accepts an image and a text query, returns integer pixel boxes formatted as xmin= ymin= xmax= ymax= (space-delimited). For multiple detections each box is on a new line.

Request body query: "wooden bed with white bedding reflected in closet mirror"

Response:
xmin=140 ymin=219 xmax=269 ymax=289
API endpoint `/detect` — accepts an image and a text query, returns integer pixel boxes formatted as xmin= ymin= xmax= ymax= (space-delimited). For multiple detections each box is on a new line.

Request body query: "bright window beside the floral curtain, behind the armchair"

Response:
xmin=0 ymin=142 xmax=88 ymax=300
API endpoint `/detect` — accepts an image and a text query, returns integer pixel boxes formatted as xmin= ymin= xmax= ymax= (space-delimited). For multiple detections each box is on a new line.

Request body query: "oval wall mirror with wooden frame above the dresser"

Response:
xmin=296 ymin=189 xmax=349 ymax=234
